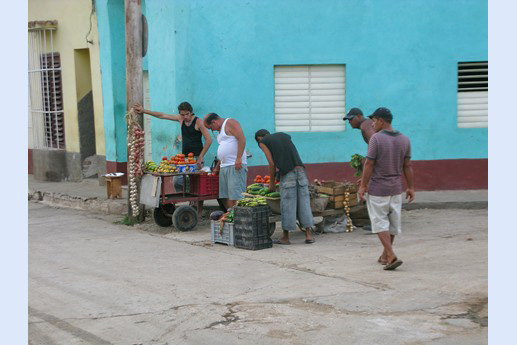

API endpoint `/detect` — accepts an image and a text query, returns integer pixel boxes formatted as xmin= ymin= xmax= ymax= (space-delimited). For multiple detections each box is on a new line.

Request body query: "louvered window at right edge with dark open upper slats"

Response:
xmin=458 ymin=61 xmax=488 ymax=128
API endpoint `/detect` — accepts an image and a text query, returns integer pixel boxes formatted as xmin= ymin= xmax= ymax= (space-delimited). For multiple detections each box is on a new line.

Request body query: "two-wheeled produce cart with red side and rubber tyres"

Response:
xmin=146 ymin=172 xmax=226 ymax=231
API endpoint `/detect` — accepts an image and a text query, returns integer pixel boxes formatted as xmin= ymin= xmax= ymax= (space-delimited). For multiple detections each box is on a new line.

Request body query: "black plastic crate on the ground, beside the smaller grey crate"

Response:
xmin=233 ymin=206 xmax=273 ymax=250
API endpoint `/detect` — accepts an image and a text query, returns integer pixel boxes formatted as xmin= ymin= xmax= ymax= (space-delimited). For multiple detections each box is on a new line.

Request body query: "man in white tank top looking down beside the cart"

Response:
xmin=204 ymin=113 xmax=248 ymax=208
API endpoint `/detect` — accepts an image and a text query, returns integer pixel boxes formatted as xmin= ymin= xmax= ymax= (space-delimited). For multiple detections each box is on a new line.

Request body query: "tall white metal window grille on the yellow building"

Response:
xmin=28 ymin=28 xmax=65 ymax=149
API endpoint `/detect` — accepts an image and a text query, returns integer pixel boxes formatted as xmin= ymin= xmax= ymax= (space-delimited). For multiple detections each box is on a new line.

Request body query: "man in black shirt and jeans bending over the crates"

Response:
xmin=255 ymin=129 xmax=314 ymax=244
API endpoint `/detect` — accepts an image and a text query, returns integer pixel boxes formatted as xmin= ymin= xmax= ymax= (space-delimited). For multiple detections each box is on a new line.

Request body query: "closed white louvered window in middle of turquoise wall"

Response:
xmin=275 ymin=65 xmax=345 ymax=132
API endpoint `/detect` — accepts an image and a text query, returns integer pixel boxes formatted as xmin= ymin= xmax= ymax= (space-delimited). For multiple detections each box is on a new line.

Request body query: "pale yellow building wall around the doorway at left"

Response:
xmin=28 ymin=0 xmax=106 ymax=155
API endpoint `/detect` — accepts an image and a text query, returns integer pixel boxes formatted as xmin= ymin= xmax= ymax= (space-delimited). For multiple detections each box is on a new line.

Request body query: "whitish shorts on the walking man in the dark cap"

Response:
xmin=366 ymin=194 xmax=402 ymax=235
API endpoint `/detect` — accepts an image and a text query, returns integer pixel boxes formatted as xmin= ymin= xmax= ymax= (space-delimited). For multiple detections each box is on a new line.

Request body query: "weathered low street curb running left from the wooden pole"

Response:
xmin=28 ymin=190 xmax=127 ymax=215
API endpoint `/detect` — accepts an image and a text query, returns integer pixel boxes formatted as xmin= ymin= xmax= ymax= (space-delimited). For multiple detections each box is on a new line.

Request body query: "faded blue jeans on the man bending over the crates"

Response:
xmin=280 ymin=167 xmax=314 ymax=231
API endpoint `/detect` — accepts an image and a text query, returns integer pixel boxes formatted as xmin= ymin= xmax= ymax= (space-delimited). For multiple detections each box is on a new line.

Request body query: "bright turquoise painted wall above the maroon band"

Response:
xmin=98 ymin=0 xmax=488 ymax=165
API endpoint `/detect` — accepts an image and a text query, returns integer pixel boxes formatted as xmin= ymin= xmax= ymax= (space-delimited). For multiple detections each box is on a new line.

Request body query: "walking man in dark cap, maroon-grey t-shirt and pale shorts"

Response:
xmin=358 ymin=107 xmax=415 ymax=270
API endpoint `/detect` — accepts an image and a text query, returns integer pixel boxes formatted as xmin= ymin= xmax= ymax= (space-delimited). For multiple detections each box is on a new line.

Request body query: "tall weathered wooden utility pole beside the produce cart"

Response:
xmin=124 ymin=0 xmax=145 ymax=223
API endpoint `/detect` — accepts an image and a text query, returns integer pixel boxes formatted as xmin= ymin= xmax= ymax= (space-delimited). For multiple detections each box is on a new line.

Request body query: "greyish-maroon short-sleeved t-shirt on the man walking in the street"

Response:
xmin=366 ymin=130 xmax=411 ymax=196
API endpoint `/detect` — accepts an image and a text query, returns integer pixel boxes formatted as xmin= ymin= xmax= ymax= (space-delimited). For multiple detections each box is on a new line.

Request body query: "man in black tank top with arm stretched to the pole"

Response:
xmin=133 ymin=102 xmax=212 ymax=215
